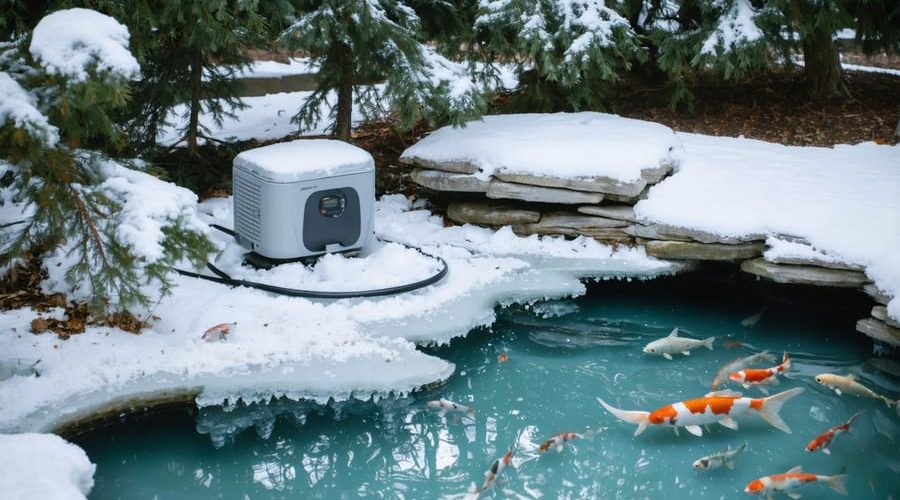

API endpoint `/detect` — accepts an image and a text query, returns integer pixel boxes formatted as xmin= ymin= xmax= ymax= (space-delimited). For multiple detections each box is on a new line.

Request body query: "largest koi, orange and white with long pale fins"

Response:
xmin=597 ymin=387 xmax=803 ymax=436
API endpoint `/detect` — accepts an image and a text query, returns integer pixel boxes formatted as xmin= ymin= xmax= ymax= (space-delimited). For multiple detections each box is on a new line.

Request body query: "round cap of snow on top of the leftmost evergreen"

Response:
xmin=28 ymin=8 xmax=141 ymax=81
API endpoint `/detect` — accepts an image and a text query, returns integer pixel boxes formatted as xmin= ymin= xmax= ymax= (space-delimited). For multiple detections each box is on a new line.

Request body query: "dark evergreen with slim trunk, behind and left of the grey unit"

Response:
xmin=81 ymin=0 xmax=290 ymax=152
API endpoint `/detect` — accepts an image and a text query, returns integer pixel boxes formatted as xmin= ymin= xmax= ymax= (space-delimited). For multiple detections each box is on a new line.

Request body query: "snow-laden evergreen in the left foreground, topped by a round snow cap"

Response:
xmin=0 ymin=9 xmax=211 ymax=314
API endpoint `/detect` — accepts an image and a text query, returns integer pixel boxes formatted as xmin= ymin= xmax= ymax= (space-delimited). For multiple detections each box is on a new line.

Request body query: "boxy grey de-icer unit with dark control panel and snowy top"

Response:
xmin=232 ymin=139 xmax=375 ymax=260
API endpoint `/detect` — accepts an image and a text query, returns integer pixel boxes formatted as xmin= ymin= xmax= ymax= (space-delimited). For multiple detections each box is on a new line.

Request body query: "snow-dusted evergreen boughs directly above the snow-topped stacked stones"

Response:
xmin=473 ymin=0 xmax=644 ymax=110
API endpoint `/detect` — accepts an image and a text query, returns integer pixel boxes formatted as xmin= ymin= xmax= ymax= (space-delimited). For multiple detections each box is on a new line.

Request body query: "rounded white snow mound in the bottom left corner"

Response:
xmin=0 ymin=434 xmax=97 ymax=500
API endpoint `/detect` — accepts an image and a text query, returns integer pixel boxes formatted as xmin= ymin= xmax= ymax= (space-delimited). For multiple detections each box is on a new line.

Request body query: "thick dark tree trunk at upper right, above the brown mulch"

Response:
xmin=803 ymin=29 xmax=850 ymax=99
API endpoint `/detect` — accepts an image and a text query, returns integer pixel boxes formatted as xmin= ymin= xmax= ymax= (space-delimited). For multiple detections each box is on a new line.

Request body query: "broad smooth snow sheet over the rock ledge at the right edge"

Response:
xmin=635 ymin=133 xmax=900 ymax=318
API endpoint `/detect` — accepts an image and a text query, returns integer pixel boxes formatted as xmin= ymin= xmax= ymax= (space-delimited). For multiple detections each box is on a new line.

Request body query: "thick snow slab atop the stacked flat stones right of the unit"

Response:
xmin=401 ymin=112 xmax=678 ymax=182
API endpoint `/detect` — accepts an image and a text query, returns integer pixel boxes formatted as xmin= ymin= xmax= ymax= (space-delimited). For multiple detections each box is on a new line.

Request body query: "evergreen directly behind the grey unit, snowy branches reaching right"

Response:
xmin=283 ymin=0 xmax=485 ymax=140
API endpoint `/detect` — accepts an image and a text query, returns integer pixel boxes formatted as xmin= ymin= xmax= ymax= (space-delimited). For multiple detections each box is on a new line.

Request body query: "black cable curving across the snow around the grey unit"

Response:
xmin=173 ymin=224 xmax=448 ymax=299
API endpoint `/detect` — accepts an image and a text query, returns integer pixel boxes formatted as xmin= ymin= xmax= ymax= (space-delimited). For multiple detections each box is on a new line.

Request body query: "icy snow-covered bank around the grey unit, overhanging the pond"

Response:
xmin=0 ymin=196 xmax=682 ymax=432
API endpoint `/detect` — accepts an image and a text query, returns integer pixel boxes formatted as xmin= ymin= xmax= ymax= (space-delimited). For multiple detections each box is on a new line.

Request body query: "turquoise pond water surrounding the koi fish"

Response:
xmin=75 ymin=272 xmax=900 ymax=499
